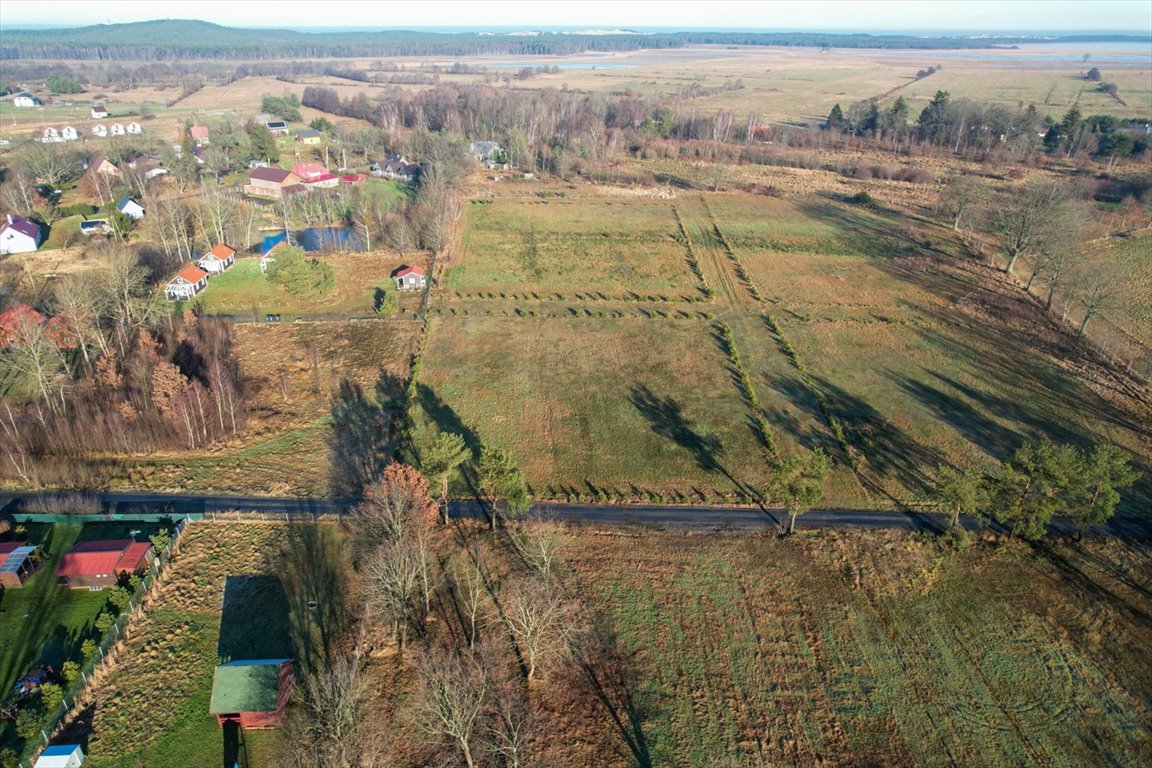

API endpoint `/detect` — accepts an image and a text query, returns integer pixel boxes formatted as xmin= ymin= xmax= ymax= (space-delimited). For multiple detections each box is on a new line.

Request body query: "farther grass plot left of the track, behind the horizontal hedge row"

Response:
xmin=446 ymin=198 xmax=699 ymax=297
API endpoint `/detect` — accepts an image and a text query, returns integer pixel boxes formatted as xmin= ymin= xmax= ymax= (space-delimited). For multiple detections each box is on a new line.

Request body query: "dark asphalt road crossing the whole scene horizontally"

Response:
xmin=0 ymin=493 xmax=1152 ymax=539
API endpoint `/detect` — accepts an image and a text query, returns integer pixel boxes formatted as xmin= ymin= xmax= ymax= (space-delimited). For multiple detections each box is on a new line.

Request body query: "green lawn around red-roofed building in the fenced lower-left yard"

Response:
xmin=0 ymin=524 xmax=163 ymax=750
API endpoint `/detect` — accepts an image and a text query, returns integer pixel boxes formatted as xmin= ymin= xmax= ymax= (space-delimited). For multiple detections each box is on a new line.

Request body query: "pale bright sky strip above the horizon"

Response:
xmin=0 ymin=0 xmax=1152 ymax=35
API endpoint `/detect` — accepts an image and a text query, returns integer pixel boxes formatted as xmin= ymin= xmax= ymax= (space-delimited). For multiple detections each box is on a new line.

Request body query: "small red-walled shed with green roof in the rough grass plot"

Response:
xmin=209 ymin=659 xmax=293 ymax=728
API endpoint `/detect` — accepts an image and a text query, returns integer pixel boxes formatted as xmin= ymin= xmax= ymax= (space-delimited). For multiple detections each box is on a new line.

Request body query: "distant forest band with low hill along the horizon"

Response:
xmin=0 ymin=21 xmax=1146 ymax=61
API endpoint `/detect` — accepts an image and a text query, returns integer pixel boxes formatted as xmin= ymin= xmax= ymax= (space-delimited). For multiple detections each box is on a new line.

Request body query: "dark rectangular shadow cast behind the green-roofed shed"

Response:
xmin=217 ymin=573 xmax=296 ymax=662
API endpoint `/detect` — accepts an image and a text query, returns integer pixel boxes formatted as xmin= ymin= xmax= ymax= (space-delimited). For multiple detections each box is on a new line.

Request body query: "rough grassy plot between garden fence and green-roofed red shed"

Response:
xmin=69 ymin=523 xmax=344 ymax=768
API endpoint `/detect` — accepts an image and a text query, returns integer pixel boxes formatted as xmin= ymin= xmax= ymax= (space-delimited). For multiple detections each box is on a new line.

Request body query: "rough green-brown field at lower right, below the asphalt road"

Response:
xmin=568 ymin=532 xmax=1152 ymax=768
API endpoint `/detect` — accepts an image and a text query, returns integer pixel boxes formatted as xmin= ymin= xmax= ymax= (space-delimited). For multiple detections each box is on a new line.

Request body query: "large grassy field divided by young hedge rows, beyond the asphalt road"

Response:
xmin=420 ymin=188 xmax=1152 ymax=514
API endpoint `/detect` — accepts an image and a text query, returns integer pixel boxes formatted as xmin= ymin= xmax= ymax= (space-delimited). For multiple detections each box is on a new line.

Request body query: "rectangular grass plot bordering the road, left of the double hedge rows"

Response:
xmin=417 ymin=317 xmax=764 ymax=497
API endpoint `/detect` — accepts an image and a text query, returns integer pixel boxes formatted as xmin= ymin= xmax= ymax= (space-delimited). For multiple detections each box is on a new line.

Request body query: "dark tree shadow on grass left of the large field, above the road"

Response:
xmin=328 ymin=373 xmax=404 ymax=499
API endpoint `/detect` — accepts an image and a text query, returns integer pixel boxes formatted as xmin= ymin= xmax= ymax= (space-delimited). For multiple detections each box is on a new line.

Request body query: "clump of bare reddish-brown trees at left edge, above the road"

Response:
xmin=0 ymin=250 xmax=247 ymax=485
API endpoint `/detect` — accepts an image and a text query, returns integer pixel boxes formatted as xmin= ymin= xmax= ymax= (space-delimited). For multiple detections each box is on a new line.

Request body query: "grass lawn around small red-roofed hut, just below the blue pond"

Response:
xmin=194 ymin=253 xmax=424 ymax=321
